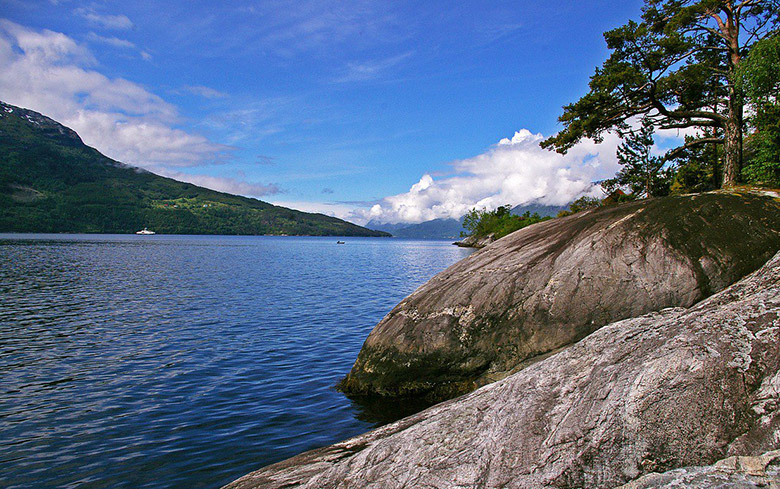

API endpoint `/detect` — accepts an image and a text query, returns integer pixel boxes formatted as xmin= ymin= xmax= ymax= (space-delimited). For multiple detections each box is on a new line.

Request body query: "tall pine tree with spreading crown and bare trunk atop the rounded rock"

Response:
xmin=542 ymin=0 xmax=780 ymax=185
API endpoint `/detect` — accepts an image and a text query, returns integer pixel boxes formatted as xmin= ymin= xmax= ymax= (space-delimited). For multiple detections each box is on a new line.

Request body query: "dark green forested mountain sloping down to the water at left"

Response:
xmin=0 ymin=102 xmax=389 ymax=236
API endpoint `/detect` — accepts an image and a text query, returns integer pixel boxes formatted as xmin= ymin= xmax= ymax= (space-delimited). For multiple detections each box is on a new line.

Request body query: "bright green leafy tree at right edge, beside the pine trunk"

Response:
xmin=739 ymin=33 xmax=780 ymax=187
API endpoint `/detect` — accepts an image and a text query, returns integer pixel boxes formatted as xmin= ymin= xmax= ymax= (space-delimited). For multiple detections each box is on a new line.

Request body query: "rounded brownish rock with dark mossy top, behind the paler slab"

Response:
xmin=340 ymin=192 xmax=780 ymax=400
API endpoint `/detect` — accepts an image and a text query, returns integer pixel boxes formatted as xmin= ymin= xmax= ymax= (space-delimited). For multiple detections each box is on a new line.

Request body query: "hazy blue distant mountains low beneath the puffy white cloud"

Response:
xmin=366 ymin=202 xmax=569 ymax=239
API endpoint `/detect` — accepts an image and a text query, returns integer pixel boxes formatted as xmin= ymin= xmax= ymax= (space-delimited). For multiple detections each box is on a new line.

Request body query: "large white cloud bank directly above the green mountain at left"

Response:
xmin=0 ymin=20 xmax=230 ymax=168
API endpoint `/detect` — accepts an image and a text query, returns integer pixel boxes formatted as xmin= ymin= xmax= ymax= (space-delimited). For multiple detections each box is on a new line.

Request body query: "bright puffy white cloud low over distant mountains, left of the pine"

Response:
xmin=358 ymin=129 xmax=620 ymax=223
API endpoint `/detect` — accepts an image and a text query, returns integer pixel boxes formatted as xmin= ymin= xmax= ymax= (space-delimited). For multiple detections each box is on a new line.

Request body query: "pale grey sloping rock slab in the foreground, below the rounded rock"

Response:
xmin=228 ymin=253 xmax=780 ymax=489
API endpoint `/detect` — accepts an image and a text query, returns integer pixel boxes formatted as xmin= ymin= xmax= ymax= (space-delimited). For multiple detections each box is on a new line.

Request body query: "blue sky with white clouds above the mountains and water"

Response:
xmin=0 ymin=0 xmax=642 ymax=224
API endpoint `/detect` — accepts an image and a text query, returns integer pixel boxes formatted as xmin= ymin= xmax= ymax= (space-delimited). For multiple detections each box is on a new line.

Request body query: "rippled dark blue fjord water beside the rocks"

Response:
xmin=0 ymin=235 xmax=469 ymax=488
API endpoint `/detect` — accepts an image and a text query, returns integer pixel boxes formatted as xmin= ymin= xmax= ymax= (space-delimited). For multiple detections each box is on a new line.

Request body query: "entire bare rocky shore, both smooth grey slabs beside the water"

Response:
xmin=226 ymin=192 xmax=780 ymax=489
